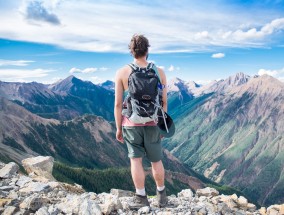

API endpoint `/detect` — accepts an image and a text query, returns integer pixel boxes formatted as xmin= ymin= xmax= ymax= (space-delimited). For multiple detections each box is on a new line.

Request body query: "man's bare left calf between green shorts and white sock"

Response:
xmin=130 ymin=158 xmax=145 ymax=189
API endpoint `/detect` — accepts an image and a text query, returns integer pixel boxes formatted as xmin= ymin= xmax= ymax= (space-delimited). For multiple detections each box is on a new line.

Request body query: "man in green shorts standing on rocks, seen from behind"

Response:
xmin=114 ymin=35 xmax=167 ymax=209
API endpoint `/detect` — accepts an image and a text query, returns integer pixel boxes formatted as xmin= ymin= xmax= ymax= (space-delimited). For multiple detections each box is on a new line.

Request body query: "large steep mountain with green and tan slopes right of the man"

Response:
xmin=166 ymin=73 xmax=284 ymax=205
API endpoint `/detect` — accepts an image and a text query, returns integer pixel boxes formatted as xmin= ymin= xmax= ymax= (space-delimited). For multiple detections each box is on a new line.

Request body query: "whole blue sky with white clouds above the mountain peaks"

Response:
xmin=0 ymin=0 xmax=284 ymax=84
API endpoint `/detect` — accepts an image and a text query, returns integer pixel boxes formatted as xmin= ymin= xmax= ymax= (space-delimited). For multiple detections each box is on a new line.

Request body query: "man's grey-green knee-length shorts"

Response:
xmin=122 ymin=126 xmax=162 ymax=162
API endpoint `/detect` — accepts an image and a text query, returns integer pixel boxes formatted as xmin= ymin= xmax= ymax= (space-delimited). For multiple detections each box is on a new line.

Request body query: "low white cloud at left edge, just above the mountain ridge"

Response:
xmin=0 ymin=69 xmax=54 ymax=81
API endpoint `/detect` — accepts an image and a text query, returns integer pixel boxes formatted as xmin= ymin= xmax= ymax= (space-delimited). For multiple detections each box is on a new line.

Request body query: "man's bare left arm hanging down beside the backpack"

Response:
xmin=114 ymin=70 xmax=123 ymax=142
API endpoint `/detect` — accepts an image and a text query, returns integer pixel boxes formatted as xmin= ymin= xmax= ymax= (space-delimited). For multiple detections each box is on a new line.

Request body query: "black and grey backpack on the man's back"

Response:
xmin=125 ymin=63 xmax=162 ymax=123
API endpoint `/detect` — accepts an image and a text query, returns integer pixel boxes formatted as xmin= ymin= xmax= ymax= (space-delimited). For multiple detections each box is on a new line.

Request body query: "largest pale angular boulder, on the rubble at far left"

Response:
xmin=22 ymin=156 xmax=55 ymax=181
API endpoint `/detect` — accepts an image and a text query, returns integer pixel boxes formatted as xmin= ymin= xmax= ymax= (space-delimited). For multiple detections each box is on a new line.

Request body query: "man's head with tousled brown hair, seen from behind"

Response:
xmin=128 ymin=34 xmax=150 ymax=58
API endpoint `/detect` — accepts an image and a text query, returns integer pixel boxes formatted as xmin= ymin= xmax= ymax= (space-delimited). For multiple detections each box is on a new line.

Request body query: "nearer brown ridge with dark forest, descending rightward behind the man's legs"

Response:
xmin=0 ymin=89 xmax=233 ymax=198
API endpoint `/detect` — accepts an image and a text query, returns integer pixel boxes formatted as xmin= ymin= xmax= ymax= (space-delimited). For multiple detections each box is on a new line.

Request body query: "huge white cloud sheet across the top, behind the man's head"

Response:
xmin=0 ymin=0 xmax=284 ymax=53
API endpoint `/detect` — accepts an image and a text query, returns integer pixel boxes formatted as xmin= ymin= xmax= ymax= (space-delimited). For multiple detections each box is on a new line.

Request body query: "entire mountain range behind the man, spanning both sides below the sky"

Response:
xmin=0 ymin=73 xmax=284 ymax=205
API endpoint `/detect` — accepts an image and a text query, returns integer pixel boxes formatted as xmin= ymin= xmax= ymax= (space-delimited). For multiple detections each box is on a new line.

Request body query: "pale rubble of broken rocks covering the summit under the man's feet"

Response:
xmin=0 ymin=156 xmax=284 ymax=215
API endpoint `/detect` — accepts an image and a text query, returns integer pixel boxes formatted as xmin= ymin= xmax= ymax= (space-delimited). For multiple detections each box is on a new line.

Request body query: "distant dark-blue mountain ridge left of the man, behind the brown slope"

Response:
xmin=0 ymin=76 xmax=114 ymax=121
